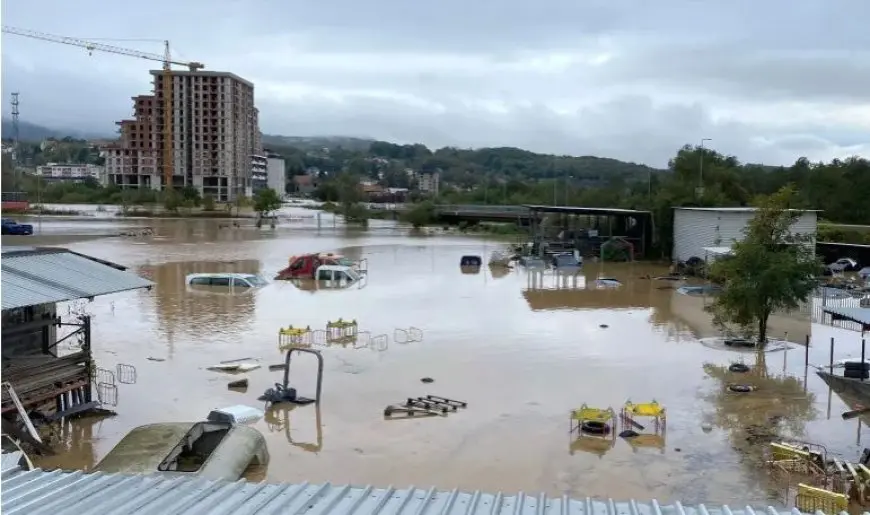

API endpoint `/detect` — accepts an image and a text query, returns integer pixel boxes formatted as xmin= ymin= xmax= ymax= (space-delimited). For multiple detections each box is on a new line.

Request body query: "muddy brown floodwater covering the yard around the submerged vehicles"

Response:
xmin=18 ymin=206 xmax=868 ymax=505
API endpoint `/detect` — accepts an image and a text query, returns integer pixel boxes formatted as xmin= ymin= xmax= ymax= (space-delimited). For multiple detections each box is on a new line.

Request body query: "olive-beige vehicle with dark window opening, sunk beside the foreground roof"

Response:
xmin=94 ymin=421 xmax=269 ymax=481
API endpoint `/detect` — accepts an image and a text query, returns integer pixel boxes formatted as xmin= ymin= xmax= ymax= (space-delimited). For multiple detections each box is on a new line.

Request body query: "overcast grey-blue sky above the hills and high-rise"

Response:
xmin=2 ymin=0 xmax=870 ymax=166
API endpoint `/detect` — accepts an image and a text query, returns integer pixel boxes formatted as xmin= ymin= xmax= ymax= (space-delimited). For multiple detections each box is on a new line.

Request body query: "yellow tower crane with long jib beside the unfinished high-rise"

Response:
xmin=3 ymin=25 xmax=205 ymax=191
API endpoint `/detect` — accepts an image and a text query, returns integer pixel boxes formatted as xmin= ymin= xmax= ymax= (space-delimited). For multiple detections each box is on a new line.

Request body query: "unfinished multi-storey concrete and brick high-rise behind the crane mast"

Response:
xmin=105 ymin=70 xmax=262 ymax=202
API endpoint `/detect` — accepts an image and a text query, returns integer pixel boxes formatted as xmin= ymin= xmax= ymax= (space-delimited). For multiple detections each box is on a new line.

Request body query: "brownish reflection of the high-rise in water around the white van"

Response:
xmin=139 ymin=259 xmax=260 ymax=344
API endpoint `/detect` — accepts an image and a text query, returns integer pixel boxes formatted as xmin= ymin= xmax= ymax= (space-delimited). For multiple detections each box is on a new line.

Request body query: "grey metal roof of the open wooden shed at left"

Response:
xmin=0 ymin=249 xmax=154 ymax=309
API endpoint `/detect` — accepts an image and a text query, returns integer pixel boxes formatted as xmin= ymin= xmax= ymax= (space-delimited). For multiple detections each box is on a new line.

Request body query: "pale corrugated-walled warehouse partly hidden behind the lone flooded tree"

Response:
xmin=672 ymin=207 xmax=818 ymax=261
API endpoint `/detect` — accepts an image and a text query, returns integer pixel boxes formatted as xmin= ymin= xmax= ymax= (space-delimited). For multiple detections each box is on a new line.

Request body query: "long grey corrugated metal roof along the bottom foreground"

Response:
xmin=0 ymin=467 xmax=845 ymax=515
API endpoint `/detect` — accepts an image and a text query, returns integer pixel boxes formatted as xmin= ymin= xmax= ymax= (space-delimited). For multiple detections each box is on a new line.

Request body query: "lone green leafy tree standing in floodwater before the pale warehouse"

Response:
xmin=710 ymin=187 xmax=821 ymax=346
